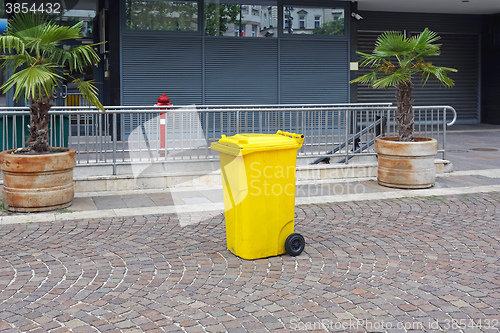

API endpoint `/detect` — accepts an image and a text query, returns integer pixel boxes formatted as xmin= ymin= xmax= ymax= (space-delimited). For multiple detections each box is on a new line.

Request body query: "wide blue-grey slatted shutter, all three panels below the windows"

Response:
xmin=122 ymin=33 xmax=349 ymax=105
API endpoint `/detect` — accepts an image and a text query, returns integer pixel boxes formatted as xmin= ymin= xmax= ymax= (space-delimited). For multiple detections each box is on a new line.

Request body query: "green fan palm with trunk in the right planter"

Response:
xmin=351 ymin=28 xmax=457 ymax=142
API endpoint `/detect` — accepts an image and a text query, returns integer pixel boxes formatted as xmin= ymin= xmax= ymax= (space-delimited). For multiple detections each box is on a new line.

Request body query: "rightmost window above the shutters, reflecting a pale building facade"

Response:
xmin=283 ymin=6 xmax=345 ymax=35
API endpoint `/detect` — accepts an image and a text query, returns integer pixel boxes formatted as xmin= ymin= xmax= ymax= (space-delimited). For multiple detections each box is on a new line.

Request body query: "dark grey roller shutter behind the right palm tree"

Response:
xmin=357 ymin=28 xmax=480 ymax=124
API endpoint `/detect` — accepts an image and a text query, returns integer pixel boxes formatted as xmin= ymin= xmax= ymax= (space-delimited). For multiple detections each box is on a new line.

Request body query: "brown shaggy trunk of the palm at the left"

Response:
xmin=27 ymin=92 xmax=53 ymax=153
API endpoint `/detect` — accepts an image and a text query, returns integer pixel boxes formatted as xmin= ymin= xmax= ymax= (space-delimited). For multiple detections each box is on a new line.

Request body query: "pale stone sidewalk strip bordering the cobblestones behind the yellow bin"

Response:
xmin=0 ymin=169 xmax=500 ymax=224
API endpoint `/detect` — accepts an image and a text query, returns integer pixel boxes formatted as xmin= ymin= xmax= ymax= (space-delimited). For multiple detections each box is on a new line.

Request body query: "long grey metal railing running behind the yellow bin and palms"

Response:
xmin=0 ymin=103 xmax=456 ymax=172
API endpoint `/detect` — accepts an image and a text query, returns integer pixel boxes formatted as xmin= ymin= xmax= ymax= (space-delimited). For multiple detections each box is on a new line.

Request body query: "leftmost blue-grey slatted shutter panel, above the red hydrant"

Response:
xmin=122 ymin=32 xmax=202 ymax=105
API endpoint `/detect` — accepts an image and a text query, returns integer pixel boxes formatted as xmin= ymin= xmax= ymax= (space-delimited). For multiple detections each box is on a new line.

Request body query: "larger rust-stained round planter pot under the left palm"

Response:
xmin=0 ymin=148 xmax=76 ymax=212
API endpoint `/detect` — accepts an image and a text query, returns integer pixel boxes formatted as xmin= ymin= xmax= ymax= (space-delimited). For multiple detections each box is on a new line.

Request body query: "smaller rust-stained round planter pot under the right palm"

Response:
xmin=375 ymin=136 xmax=437 ymax=189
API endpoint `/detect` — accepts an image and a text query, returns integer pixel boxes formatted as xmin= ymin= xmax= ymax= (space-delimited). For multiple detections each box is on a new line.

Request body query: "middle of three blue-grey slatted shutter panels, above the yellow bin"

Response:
xmin=205 ymin=37 xmax=278 ymax=104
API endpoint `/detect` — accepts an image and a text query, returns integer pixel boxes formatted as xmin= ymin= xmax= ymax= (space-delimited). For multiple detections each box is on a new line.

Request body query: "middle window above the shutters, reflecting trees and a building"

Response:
xmin=204 ymin=0 xmax=278 ymax=37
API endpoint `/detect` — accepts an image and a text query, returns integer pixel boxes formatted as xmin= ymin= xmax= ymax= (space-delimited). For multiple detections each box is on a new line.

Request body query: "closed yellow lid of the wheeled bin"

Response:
xmin=210 ymin=131 xmax=304 ymax=156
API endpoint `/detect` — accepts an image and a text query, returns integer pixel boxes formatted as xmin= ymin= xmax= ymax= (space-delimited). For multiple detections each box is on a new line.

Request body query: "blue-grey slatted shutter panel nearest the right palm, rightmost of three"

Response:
xmin=280 ymin=39 xmax=349 ymax=103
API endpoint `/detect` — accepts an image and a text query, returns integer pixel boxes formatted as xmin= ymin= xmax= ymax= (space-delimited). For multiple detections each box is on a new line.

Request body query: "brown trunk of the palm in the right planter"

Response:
xmin=396 ymin=82 xmax=414 ymax=142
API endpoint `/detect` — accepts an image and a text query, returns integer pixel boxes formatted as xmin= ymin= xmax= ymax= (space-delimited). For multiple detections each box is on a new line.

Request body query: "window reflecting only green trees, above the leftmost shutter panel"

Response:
xmin=125 ymin=0 xmax=198 ymax=31
